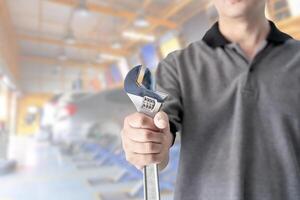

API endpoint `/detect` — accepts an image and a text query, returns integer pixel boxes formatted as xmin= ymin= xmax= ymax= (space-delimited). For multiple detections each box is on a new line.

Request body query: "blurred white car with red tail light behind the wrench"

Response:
xmin=54 ymin=89 xmax=135 ymax=148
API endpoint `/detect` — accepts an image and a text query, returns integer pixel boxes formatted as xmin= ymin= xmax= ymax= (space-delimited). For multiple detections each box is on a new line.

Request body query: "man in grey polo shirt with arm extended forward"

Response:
xmin=122 ymin=0 xmax=300 ymax=200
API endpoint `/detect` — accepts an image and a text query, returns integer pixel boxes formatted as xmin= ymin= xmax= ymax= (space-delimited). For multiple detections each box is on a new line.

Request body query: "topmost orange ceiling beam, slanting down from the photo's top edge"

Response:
xmin=50 ymin=0 xmax=177 ymax=29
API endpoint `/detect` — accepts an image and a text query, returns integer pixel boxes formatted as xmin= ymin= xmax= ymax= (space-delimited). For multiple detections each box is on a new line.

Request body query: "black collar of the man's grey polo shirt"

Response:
xmin=202 ymin=21 xmax=292 ymax=48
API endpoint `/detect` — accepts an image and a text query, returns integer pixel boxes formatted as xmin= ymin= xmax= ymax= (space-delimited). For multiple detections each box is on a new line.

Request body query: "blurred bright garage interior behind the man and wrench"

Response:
xmin=0 ymin=0 xmax=300 ymax=200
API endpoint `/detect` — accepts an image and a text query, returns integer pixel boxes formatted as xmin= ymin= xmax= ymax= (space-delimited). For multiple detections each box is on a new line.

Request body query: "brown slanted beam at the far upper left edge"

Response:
xmin=0 ymin=0 xmax=19 ymax=81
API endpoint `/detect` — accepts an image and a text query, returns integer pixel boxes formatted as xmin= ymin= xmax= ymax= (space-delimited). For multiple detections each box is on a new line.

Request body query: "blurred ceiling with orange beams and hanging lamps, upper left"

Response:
xmin=7 ymin=0 xmax=206 ymax=70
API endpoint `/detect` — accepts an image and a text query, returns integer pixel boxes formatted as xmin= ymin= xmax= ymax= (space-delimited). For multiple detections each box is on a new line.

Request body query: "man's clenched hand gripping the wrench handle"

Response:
xmin=121 ymin=112 xmax=173 ymax=170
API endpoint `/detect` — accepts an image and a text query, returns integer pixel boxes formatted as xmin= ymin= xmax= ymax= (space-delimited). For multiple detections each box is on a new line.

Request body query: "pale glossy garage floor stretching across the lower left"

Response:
xmin=0 ymin=138 xmax=172 ymax=200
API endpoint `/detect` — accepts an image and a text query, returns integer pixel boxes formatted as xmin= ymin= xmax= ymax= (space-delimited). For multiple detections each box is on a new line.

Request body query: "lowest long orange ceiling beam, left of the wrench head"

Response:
xmin=21 ymin=56 xmax=113 ymax=69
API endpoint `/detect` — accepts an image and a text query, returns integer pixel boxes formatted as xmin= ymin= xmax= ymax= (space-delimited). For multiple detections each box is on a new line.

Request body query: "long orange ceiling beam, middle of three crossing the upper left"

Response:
xmin=18 ymin=34 xmax=128 ymax=56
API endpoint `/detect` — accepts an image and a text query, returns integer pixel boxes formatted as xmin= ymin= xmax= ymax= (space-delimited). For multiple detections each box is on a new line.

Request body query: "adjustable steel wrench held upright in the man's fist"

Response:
xmin=124 ymin=65 xmax=167 ymax=200
